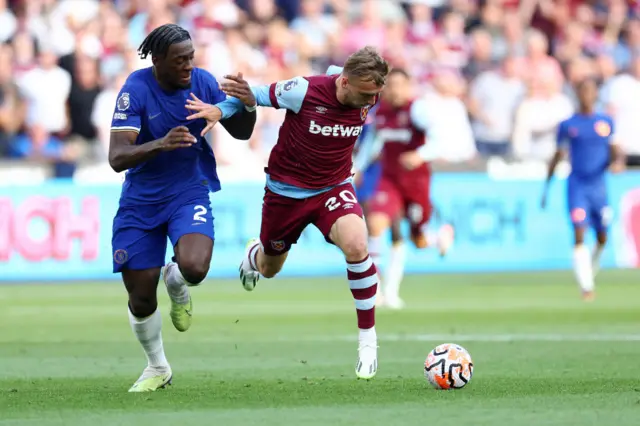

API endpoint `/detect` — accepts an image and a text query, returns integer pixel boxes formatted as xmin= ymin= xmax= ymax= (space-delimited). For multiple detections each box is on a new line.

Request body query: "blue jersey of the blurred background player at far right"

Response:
xmin=558 ymin=114 xmax=614 ymax=180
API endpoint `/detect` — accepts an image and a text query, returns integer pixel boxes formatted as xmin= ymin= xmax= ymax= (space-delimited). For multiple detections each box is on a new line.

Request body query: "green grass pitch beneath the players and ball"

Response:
xmin=0 ymin=271 xmax=640 ymax=426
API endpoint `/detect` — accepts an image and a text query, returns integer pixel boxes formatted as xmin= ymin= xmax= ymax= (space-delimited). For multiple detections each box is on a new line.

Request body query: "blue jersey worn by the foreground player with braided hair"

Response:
xmin=111 ymin=68 xmax=226 ymax=205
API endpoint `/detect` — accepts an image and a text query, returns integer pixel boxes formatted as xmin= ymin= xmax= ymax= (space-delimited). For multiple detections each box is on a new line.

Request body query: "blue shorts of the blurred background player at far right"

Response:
xmin=567 ymin=178 xmax=613 ymax=233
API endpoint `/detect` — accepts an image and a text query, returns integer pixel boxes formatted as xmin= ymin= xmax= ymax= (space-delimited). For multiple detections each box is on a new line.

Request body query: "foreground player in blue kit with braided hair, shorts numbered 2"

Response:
xmin=109 ymin=24 xmax=256 ymax=392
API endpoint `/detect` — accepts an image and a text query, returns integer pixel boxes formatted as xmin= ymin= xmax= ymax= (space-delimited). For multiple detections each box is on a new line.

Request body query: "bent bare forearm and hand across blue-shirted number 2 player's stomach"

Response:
xmin=109 ymin=126 xmax=197 ymax=173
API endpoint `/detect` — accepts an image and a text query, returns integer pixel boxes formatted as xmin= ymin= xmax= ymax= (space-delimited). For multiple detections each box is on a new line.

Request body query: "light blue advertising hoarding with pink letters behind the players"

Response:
xmin=0 ymin=172 xmax=640 ymax=281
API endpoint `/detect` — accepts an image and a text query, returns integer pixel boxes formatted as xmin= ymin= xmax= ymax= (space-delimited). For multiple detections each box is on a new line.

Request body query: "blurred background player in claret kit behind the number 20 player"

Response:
xmin=356 ymin=69 xmax=453 ymax=309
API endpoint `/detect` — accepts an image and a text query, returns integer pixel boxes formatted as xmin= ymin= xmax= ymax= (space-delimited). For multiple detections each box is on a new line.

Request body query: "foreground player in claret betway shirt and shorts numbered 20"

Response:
xmin=185 ymin=47 xmax=389 ymax=379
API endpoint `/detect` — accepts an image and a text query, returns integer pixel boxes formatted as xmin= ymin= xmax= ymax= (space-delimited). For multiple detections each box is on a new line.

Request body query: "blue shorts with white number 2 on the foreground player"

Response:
xmin=111 ymin=191 xmax=215 ymax=273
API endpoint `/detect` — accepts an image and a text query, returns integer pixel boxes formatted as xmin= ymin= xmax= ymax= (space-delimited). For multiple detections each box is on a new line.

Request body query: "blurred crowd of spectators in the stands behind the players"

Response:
xmin=0 ymin=0 xmax=640 ymax=181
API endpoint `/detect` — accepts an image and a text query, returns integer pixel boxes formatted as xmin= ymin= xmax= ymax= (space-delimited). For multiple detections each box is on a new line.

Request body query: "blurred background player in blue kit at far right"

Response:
xmin=542 ymin=79 xmax=624 ymax=300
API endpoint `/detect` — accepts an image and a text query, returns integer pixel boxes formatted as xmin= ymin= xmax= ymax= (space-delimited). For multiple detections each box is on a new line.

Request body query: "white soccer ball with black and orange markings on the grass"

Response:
xmin=424 ymin=343 xmax=473 ymax=389
